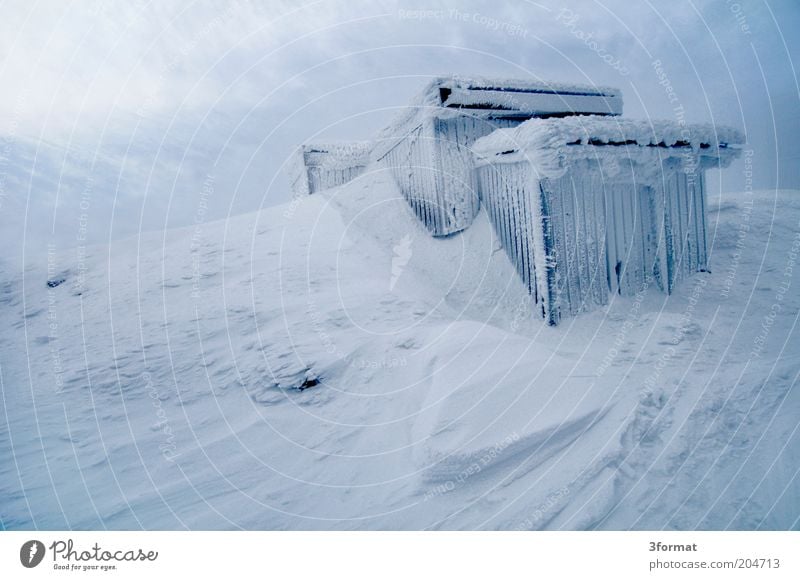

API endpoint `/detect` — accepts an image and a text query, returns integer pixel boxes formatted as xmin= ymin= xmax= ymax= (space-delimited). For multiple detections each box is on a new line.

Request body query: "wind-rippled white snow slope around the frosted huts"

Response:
xmin=0 ymin=170 xmax=800 ymax=529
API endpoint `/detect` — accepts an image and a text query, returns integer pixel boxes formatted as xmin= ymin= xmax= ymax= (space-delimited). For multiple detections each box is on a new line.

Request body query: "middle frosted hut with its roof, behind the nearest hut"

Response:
xmin=372 ymin=77 xmax=622 ymax=236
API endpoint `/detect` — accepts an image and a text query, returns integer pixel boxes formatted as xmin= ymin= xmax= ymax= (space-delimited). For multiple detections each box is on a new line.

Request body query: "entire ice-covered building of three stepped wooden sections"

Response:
xmin=292 ymin=77 xmax=744 ymax=324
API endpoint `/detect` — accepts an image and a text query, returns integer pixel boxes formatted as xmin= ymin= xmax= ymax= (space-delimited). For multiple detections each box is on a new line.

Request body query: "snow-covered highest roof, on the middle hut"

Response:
xmin=376 ymin=76 xmax=622 ymax=157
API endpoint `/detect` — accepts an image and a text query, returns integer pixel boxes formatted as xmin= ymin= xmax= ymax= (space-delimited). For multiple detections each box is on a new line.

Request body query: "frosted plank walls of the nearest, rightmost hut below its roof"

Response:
xmin=477 ymin=156 xmax=707 ymax=324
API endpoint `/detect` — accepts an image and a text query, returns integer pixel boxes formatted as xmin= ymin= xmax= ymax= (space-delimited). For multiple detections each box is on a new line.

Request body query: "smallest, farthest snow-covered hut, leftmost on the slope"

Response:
xmin=289 ymin=141 xmax=371 ymax=195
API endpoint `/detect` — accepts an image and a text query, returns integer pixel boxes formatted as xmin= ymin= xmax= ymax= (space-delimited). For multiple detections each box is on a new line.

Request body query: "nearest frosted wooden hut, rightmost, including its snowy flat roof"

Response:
xmin=473 ymin=116 xmax=743 ymax=324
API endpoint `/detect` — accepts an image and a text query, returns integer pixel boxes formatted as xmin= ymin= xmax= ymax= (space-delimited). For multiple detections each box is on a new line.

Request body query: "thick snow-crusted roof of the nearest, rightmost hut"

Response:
xmin=472 ymin=116 xmax=745 ymax=175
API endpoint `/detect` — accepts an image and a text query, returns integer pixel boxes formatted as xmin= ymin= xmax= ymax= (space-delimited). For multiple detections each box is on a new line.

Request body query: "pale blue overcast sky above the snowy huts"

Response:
xmin=0 ymin=0 xmax=800 ymax=264
